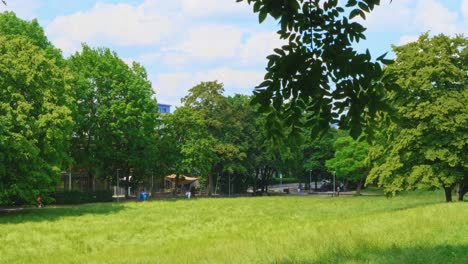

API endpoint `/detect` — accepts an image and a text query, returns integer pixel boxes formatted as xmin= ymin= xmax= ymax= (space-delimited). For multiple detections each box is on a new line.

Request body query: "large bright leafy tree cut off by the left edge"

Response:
xmin=0 ymin=35 xmax=73 ymax=203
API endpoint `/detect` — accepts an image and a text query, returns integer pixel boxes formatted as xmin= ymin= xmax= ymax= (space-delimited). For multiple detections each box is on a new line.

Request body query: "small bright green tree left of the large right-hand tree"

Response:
xmin=326 ymin=136 xmax=369 ymax=195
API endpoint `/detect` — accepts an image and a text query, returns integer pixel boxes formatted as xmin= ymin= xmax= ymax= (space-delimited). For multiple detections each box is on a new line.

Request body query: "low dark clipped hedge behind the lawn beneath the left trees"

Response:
xmin=53 ymin=191 xmax=113 ymax=204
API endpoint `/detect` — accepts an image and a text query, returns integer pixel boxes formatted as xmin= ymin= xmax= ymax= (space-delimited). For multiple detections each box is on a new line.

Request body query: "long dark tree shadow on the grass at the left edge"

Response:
xmin=0 ymin=203 xmax=124 ymax=224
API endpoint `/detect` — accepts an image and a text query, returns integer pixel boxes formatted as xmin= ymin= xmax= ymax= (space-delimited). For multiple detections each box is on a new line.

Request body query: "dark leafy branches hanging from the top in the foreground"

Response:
xmin=237 ymin=0 xmax=389 ymax=138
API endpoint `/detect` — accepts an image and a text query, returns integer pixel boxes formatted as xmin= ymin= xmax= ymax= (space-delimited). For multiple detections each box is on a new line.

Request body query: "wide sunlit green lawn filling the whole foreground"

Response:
xmin=0 ymin=192 xmax=468 ymax=263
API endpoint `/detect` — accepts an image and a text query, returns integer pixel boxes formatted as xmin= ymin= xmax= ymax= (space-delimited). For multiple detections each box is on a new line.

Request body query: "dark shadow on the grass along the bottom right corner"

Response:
xmin=273 ymin=245 xmax=468 ymax=264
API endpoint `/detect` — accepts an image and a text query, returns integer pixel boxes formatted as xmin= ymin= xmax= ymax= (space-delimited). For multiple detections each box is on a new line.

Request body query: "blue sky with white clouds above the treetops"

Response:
xmin=0 ymin=0 xmax=468 ymax=105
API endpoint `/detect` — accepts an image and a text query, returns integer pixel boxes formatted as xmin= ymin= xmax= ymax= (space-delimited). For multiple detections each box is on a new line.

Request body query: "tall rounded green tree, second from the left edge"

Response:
xmin=69 ymin=45 xmax=158 ymax=195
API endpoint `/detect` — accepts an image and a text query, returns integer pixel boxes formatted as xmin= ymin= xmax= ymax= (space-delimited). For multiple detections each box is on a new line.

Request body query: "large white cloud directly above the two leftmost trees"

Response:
xmin=47 ymin=3 xmax=172 ymax=53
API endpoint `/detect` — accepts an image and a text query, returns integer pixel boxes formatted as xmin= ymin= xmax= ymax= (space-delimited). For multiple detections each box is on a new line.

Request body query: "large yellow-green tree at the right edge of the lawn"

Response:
xmin=367 ymin=33 xmax=468 ymax=202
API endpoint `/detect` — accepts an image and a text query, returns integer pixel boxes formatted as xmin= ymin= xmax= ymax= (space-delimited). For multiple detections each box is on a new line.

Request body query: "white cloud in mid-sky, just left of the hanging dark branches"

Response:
xmin=139 ymin=29 xmax=285 ymax=67
